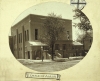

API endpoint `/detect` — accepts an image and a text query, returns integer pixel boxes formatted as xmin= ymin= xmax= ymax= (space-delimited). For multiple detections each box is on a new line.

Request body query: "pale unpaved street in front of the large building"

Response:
xmin=19 ymin=60 xmax=81 ymax=72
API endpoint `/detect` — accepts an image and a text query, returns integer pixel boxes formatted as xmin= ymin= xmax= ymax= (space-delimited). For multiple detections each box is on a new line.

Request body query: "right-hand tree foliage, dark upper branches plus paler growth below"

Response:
xmin=73 ymin=9 xmax=92 ymax=47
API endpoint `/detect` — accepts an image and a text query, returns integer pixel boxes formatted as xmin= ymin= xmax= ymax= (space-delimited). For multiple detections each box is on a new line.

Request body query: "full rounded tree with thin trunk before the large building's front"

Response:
xmin=41 ymin=13 xmax=65 ymax=60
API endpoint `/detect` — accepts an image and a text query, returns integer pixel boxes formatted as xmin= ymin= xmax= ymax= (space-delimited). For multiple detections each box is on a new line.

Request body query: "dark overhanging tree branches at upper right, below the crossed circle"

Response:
xmin=73 ymin=9 xmax=92 ymax=32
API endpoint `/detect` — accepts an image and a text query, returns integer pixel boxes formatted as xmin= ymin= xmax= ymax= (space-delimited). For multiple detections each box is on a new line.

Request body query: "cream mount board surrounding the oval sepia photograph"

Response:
xmin=0 ymin=0 xmax=100 ymax=81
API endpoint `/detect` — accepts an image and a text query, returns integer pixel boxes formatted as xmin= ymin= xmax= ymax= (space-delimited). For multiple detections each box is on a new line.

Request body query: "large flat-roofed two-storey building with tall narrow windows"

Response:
xmin=11 ymin=14 xmax=72 ymax=59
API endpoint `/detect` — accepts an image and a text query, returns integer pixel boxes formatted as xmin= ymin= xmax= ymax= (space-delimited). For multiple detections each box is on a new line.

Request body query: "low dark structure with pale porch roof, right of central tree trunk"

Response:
xmin=55 ymin=40 xmax=83 ymax=58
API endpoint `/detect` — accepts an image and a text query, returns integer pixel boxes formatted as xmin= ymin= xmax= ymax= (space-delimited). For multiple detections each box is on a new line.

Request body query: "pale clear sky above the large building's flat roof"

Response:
xmin=12 ymin=2 xmax=79 ymax=40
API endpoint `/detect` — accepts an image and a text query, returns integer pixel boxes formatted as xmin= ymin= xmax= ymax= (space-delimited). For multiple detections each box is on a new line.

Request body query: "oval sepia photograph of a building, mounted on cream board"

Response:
xmin=9 ymin=2 xmax=93 ymax=72
